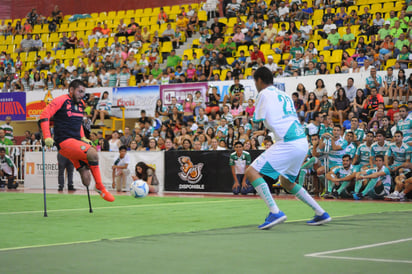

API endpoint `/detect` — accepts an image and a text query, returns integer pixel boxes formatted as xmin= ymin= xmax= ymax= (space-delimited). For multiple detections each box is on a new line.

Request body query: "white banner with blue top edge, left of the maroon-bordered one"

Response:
xmin=112 ymin=86 xmax=159 ymax=118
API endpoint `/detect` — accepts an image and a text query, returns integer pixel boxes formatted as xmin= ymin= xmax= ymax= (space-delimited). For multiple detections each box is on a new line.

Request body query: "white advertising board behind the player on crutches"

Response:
xmin=24 ymin=151 xmax=165 ymax=191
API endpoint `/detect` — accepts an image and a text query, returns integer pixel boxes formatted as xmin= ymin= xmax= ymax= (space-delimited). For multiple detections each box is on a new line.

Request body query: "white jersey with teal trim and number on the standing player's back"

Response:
xmin=253 ymin=86 xmax=306 ymax=142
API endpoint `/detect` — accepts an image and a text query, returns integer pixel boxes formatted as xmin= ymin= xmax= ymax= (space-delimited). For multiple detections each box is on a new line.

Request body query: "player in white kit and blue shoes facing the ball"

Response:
xmin=246 ymin=67 xmax=332 ymax=229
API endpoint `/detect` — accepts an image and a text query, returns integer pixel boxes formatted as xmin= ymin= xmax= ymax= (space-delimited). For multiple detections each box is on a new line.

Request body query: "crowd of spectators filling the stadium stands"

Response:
xmin=1 ymin=0 xmax=412 ymax=198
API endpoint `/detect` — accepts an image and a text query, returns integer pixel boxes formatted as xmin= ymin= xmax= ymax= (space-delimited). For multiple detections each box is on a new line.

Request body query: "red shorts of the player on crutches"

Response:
xmin=59 ymin=138 xmax=91 ymax=169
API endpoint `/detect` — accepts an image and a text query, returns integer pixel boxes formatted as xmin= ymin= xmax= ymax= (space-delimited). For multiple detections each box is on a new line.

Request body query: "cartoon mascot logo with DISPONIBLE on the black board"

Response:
xmin=177 ymin=156 xmax=205 ymax=189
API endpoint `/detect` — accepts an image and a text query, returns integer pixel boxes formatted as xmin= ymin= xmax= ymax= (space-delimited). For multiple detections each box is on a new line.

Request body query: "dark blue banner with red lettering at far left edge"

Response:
xmin=0 ymin=92 xmax=26 ymax=121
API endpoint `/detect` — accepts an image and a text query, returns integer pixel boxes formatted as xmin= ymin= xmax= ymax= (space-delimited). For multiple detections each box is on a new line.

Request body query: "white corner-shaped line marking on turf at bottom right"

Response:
xmin=305 ymin=238 xmax=412 ymax=264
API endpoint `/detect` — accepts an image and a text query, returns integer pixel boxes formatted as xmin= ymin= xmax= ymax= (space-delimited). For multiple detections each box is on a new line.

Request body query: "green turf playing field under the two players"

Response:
xmin=0 ymin=193 xmax=412 ymax=273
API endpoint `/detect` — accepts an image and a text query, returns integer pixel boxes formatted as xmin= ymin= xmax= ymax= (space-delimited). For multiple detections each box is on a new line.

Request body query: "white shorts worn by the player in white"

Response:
xmin=251 ymin=138 xmax=308 ymax=182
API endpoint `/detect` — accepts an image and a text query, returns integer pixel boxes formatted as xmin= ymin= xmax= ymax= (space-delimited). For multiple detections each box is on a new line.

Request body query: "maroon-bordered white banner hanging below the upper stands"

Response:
xmin=160 ymin=83 xmax=208 ymax=107
